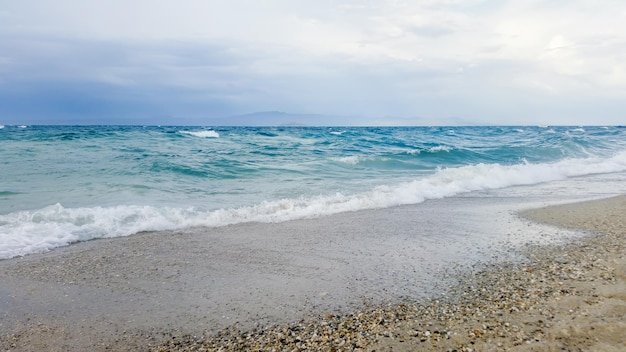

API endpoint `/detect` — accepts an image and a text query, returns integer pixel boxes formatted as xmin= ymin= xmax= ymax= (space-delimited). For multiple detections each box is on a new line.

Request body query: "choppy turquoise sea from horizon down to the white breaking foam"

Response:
xmin=0 ymin=125 xmax=626 ymax=259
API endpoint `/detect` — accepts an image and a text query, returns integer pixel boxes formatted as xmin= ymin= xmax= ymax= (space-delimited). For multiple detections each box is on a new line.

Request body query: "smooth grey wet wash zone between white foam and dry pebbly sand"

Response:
xmin=0 ymin=173 xmax=626 ymax=334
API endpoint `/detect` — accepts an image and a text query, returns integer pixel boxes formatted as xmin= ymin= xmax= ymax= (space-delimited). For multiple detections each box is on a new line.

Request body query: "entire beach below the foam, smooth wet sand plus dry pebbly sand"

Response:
xmin=0 ymin=196 xmax=626 ymax=351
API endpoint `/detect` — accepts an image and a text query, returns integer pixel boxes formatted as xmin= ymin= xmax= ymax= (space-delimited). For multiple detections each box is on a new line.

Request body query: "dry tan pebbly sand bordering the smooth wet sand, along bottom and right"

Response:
xmin=0 ymin=196 xmax=626 ymax=352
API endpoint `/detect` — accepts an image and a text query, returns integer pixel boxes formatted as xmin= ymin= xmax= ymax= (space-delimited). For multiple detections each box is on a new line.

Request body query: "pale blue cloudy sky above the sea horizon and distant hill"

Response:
xmin=0 ymin=0 xmax=626 ymax=125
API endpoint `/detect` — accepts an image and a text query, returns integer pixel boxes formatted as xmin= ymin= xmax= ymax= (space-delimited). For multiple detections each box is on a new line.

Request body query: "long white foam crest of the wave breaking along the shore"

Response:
xmin=0 ymin=152 xmax=626 ymax=259
